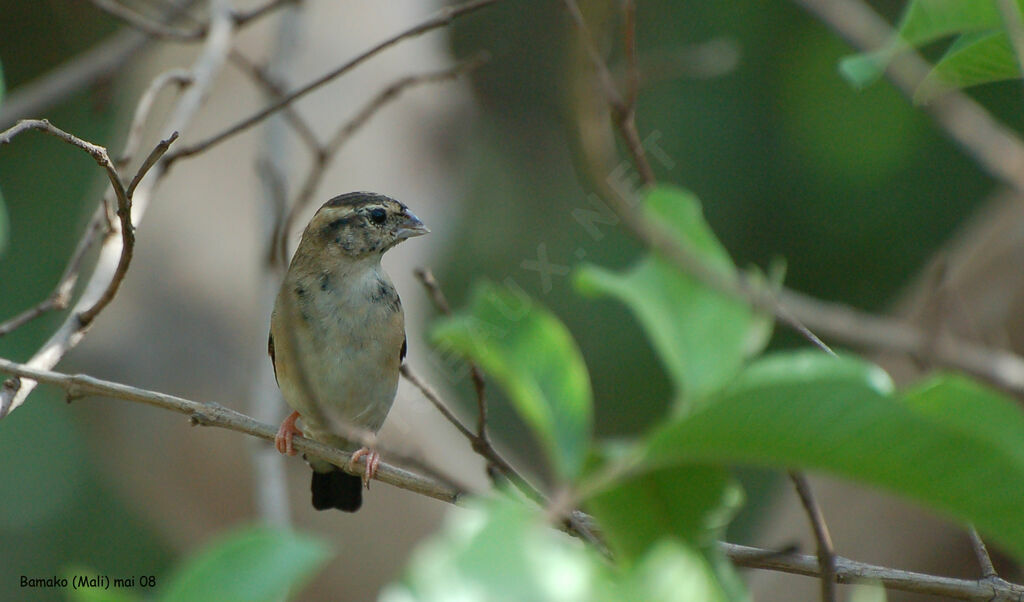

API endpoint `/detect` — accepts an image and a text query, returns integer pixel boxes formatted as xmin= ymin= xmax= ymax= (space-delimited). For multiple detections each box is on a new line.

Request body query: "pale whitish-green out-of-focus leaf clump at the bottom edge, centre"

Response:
xmin=380 ymin=498 xmax=727 ymax=602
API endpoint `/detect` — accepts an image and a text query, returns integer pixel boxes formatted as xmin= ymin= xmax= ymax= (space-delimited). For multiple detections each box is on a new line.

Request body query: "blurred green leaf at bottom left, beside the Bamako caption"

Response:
xmin=158 ymin=526 xmax=331 ymax=602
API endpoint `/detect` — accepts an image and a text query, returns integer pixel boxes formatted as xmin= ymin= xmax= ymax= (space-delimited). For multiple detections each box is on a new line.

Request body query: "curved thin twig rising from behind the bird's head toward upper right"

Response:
xmin=271 ymin=52 xmax=488 ymax=265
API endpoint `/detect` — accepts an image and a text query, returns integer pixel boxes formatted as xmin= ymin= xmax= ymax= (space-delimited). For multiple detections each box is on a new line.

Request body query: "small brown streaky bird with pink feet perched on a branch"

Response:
xmin=268 ymin=192 xmax=430 ymax=512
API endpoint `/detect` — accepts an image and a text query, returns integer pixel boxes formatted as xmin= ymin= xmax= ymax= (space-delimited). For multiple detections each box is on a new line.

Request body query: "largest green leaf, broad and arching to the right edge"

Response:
xmin=645 ymin=352 xmax=1024 ymax=560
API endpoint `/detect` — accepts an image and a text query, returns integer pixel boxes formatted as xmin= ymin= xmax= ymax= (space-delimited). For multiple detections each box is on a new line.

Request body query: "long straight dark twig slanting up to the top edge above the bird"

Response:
xmin=166 ymin=0 xmax=498 ymax=164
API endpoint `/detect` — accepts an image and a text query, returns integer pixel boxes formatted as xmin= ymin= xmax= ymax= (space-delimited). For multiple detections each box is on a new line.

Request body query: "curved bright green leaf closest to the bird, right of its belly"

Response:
xmin=432 ymin=283 xmax=593 ymax=479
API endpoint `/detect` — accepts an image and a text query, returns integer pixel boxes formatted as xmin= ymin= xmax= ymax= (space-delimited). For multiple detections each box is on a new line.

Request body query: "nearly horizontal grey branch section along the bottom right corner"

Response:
xmin=719 ymin=543 xmax=1024 ymax=602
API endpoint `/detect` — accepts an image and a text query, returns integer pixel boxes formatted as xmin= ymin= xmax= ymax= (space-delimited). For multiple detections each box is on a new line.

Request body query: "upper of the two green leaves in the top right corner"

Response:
xmin=840 ymin=0 xmax=1001 ymax=87
